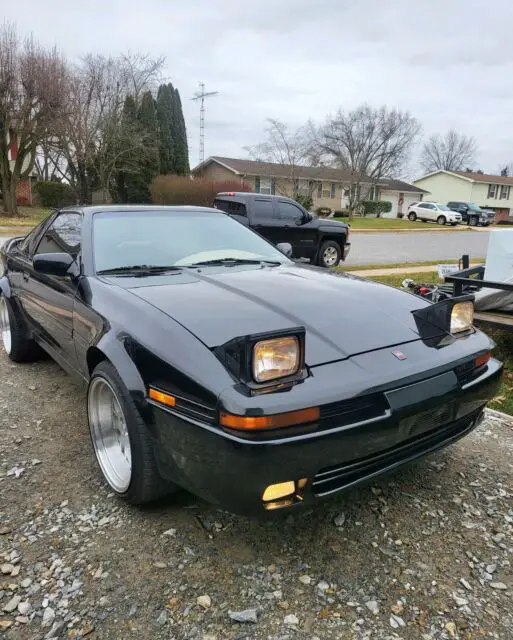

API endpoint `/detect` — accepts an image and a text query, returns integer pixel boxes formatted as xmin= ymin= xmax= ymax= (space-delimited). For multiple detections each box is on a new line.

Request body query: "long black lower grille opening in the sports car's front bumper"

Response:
xmin=312 ymin=410 xmax=481 ymax=497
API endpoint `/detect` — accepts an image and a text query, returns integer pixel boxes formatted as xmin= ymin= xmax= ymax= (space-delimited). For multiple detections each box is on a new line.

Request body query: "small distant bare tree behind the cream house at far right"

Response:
xmin=420 ymin=129 xmax=477 ymax=172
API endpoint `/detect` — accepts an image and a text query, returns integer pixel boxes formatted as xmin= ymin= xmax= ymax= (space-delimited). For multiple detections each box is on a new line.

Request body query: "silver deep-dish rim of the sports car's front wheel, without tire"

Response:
xmin=87 ymin=377 xmax=132 ymax=493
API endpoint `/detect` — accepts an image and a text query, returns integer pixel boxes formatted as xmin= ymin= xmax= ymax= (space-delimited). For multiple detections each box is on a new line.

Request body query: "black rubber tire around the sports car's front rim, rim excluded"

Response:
xmin=87 ymin=360 xmax=179 ymax=505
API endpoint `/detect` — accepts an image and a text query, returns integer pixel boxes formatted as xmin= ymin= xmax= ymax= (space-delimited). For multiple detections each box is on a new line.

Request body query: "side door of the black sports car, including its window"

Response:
xmin=22 ymin=211 xmax=82 ymax=369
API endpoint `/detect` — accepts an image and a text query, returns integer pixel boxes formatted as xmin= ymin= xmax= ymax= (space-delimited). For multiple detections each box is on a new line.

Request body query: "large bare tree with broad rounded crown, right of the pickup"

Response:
xmin=316 ymin=105 xmax=420 ymax=211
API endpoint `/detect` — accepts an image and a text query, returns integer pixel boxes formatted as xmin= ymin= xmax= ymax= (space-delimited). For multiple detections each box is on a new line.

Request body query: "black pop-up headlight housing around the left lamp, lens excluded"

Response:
xmin=213 ymin=327 xmax=307 ymax=391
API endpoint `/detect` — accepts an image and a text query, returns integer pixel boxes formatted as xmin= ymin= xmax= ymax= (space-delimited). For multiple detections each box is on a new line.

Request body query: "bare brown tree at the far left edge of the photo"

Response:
xmin=0 ymin=24 xmax=68 ymax=215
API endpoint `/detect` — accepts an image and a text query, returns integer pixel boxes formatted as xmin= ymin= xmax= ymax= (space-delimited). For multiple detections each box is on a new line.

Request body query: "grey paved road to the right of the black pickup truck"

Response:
xmin=0 ymin=231 xmax=489 ymax=265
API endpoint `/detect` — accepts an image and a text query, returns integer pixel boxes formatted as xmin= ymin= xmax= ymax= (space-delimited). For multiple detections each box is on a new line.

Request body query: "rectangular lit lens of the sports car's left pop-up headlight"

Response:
xmin=253 ymin=336 xmax=300 ymax=382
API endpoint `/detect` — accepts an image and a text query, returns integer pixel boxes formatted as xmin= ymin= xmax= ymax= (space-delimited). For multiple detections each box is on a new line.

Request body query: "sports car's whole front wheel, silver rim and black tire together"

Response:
xmin=87 ymin=361 xmax=176 ymax=504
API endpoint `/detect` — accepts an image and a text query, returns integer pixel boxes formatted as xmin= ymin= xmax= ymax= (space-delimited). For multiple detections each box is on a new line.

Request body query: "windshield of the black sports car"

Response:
xmin=93 ymin=211 xmax=291 ymax=271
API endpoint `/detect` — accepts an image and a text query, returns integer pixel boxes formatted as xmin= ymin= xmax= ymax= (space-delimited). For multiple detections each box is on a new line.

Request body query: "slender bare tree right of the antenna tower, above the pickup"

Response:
xmin=245 ymin=118 xmax=314 ymax=198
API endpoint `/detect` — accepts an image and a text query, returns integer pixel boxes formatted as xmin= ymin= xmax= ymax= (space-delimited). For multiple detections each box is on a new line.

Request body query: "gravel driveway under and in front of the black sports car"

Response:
xmin=0 ymin=349 xmax=513 ymax=640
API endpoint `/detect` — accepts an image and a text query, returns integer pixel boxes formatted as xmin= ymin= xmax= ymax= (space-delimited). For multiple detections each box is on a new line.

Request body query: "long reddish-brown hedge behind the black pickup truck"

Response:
xmin=150 ymin=174 xmax=250 ymax=207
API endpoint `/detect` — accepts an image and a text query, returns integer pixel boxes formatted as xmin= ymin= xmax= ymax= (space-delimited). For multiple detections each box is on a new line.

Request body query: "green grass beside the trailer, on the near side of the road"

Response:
xmin=360 ymin=272 xmax=513 ymax=415
